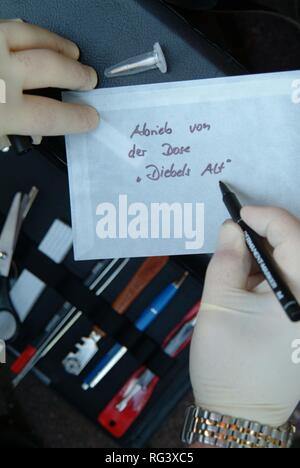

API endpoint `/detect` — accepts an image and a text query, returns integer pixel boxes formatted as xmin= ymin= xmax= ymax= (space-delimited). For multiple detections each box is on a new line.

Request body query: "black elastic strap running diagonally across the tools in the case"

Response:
xmin=22 ymin=248 xmax=174 ymax=377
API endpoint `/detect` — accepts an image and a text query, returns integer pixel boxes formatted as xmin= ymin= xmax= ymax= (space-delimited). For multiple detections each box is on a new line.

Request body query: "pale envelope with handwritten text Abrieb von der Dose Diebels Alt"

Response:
xmin=64 ymin=72 xmax=300 ymax=260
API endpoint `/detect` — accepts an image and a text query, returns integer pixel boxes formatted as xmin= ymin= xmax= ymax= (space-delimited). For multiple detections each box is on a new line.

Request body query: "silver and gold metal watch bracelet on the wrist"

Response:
xmin=181 ymin=406 xmax=296 ymax=448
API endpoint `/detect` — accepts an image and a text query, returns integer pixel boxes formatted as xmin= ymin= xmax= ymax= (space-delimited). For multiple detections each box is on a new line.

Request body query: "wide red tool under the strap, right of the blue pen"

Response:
xmin=98 ymin=302 xmax=200 ymax=438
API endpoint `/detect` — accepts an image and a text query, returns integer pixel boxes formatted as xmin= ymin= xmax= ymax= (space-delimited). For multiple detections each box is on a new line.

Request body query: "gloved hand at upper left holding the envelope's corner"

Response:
xmin=0 ymin=20 xmax=99 ymax=142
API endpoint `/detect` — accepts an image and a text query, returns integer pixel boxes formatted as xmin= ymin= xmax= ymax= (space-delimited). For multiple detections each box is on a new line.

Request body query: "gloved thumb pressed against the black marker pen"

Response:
xmin=206 ymin=221 xmax=252 ymax=289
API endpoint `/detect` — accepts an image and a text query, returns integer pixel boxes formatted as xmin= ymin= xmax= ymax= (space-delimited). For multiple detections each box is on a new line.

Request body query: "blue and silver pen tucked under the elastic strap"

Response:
xmin=82 ymin=272 xmax=188 ymax=390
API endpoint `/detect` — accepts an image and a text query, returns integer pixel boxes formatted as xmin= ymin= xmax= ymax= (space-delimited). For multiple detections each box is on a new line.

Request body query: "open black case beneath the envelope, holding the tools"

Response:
xmin=0 ymin=0 xmax=243 ymax=447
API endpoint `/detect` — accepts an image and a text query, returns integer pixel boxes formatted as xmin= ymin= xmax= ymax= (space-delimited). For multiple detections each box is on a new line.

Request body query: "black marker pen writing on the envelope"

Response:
xmin=220 ymin=182 xmax=300 ymax=322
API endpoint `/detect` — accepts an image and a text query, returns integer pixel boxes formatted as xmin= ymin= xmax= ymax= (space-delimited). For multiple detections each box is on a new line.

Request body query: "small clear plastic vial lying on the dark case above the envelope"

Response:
xmin=104 ymin=42 xmax=168 ymax=78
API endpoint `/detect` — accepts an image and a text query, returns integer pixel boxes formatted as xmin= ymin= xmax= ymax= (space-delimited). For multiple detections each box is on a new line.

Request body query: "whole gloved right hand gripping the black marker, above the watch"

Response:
xmin=190 ymin=207 xmax=300 ymax=427
